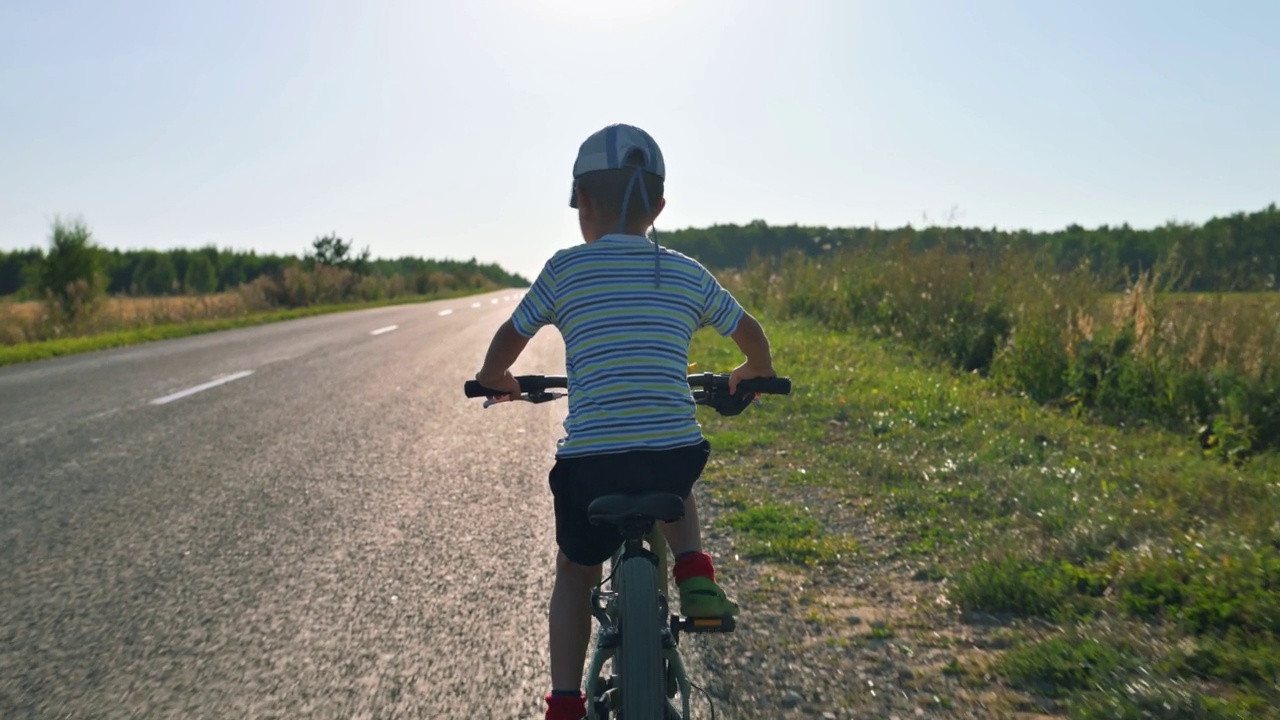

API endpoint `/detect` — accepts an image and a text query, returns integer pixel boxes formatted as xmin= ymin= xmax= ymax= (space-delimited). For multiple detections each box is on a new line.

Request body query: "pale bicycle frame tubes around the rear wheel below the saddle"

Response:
xmin=584 ymin=523 xmax=692 ymax=720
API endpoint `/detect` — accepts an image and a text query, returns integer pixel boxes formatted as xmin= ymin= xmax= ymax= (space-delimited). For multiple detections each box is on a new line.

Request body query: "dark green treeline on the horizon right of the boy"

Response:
xmin=660 ymin=204 xmax=1280 ymax=292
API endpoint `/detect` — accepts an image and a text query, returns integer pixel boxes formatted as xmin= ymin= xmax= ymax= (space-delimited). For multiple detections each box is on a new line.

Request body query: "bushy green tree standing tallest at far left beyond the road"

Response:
xmin=36 ymin=213 xmax=106 ymax=319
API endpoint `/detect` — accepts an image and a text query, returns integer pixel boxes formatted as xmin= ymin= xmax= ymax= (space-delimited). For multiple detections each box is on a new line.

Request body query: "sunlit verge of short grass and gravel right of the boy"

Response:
xmin=691 ymin=315 xmax=1280 ymax=719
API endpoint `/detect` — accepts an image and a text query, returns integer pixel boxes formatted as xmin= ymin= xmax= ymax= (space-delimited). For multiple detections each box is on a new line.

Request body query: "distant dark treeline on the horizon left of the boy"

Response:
xmin=0 ymin=236 xmax=529 ymax=300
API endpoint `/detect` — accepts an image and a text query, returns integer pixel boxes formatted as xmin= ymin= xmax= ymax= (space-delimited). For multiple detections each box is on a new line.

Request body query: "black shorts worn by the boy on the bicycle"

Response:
xmin=550 ymin=441 xmax=712 ymax=566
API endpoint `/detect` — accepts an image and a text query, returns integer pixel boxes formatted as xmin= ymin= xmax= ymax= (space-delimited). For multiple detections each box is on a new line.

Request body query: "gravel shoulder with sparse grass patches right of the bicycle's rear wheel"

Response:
xmin=699 ymin=476 xmax=1052 ymax=720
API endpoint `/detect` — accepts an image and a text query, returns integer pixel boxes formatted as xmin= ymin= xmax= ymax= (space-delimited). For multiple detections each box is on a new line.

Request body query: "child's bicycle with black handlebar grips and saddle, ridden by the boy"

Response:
xmin=465 ymin=373 xmax=791 ymax=720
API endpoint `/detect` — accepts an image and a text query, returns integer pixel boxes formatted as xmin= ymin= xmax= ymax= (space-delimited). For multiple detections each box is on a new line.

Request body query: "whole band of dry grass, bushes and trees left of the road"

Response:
xmin=0 ymin=213 xmax=529 ymax=365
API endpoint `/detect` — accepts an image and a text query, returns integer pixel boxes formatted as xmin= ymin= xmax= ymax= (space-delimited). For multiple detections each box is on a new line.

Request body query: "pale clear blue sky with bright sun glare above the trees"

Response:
xmin=0 ymin=0 xmax=1280 ymax=277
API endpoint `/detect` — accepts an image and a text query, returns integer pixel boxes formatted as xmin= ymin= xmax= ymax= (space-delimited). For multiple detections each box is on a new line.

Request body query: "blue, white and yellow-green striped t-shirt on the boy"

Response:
xmin=512 ymin=234 xmax=744 ymax=457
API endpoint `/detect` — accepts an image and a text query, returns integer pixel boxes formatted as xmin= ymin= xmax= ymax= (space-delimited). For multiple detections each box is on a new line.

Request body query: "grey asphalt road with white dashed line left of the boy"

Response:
xmin=0 ymin=291 xmax=629 ymax=719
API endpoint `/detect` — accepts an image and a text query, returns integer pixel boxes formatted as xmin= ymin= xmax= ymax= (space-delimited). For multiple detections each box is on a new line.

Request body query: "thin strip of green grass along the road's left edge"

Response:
xmin=0 ymin=285 xmax=488 ymax=366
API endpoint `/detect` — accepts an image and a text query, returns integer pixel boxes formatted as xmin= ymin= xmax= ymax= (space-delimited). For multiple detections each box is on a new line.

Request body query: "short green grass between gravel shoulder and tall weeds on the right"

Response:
xmin=691 ymin=318 xmax=1280 ymax=717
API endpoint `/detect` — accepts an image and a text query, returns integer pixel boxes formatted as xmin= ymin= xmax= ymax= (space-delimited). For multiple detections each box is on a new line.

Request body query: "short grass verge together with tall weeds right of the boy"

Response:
xmin=675 ymin=210 xmax=1280 ymax=719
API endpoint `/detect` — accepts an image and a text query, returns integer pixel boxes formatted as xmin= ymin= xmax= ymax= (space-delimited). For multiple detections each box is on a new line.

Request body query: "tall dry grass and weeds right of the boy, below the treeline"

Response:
xmin=724 ymin=238 xmax=1280 ymax=460
